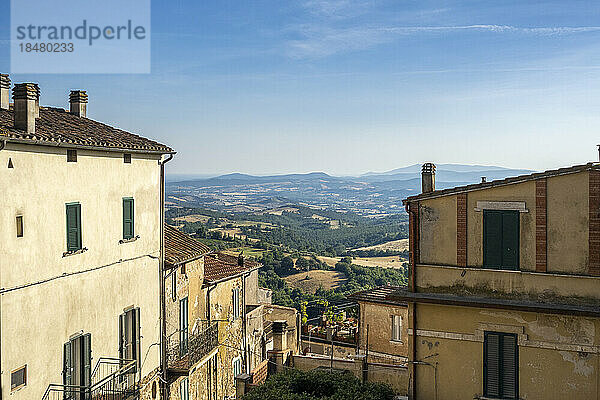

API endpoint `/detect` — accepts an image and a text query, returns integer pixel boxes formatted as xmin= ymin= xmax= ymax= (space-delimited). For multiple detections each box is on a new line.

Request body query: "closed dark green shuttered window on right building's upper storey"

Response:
xmin=483 ymin=210 xmax=519 ymax=270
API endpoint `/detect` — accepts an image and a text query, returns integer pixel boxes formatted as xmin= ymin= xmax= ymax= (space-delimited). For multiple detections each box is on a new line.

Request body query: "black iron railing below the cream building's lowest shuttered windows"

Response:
xmin=42 ymin=357 xmax=138 ymax=400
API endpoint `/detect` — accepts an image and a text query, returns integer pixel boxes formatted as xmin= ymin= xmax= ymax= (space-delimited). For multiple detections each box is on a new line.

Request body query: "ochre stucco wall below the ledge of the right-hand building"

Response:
xmin=416 ymin=304 xmax=600 ymax=400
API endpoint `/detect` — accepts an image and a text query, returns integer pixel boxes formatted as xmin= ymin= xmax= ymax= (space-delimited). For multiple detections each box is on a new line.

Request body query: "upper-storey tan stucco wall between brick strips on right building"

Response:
xmin=419 ymin=172 xmax=589 ymax=274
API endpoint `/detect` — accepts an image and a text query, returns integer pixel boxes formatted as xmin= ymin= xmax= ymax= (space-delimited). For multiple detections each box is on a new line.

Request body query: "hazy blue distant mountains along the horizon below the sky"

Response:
xmin=167 ymin=164 xmax=533 ymax=217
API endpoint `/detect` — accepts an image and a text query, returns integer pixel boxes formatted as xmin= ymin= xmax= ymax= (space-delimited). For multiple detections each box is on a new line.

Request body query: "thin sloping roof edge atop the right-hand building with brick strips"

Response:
xmin=402 ymin=163 xmax=600 ymax=205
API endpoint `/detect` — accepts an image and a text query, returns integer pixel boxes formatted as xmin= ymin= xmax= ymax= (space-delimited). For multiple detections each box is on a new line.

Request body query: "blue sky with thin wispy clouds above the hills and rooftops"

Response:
xmin=0 ymin=0 xmax=600 ymax=174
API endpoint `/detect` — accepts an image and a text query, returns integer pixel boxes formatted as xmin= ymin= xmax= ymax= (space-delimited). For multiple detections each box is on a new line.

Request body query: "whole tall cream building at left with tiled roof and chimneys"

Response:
xmin=0 ymin=75 xmax=173 ymax=400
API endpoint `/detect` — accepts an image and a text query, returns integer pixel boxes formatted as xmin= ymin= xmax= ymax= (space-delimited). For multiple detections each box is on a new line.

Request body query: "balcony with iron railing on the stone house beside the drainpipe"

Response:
xmin=167 ymin=322 xmax=219 ymax=375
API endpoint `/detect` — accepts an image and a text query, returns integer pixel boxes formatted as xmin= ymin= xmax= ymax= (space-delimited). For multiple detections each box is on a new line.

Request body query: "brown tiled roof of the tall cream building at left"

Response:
xmin=0 ymin=107 xmax=174 ymax=154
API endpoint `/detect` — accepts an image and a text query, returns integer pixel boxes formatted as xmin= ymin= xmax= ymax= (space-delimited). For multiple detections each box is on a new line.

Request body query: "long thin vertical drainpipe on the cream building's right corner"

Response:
xmin=158 ymin=154 xmax=173 ymax=399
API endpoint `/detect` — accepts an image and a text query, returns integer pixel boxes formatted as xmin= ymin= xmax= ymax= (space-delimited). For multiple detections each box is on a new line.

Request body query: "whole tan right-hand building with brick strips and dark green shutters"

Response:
xmin=392 ymin=163 xmax=600 ymax=400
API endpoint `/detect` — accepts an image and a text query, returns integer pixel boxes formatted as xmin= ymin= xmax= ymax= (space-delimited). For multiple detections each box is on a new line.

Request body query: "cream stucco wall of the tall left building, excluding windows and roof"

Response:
xmin=0 ymin=144 xmax=160 ymax=399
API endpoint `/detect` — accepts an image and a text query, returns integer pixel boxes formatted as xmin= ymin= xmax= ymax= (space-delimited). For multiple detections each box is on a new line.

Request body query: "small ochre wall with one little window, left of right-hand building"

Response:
xmin=359 ymin=302 xmax=408 ymax=357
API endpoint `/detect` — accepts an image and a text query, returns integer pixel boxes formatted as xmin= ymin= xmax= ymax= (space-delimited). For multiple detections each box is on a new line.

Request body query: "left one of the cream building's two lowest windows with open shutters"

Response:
xmin=62 ymin=333 xmax=92 ymax=399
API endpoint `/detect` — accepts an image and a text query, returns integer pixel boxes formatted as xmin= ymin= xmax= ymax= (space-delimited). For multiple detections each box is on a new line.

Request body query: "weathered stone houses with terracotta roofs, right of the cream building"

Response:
xmin=165 ymin=226 xmax=297 ymax=400
